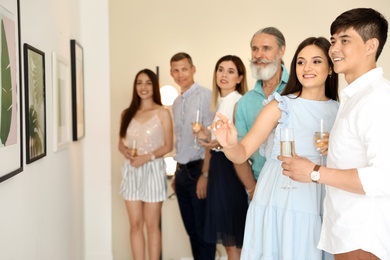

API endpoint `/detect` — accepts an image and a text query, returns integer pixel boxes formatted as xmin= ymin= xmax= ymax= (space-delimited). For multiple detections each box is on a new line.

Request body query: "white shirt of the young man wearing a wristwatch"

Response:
xmin=319 ymin=68 xmax=390 ymax=259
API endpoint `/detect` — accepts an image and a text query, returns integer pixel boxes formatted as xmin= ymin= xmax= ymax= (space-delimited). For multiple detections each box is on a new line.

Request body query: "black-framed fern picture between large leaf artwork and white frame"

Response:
xmin=23 ymin=43 xmax=46 ymax=163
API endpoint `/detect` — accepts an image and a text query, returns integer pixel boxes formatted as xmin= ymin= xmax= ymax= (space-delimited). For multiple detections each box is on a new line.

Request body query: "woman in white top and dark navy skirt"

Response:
xmin=200 ymin=55 xmax=248 ymax=260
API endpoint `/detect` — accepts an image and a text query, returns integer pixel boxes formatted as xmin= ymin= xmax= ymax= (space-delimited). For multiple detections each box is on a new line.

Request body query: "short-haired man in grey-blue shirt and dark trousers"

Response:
xmin=170 ymin=52 xmax=216 ymax=260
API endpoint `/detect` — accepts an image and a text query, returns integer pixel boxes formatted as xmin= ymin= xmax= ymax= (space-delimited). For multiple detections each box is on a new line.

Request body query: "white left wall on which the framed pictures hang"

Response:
xmin=0 ymin=0 xmax=113 ymax=260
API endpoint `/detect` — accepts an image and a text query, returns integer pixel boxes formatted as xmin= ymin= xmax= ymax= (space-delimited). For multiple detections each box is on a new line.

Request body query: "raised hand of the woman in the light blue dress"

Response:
xmin=209 ymin=112 xmax=237 ymax=149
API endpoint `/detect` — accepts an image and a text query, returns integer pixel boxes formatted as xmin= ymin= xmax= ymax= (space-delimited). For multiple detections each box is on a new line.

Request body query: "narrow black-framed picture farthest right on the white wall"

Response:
xmin=70 ymin=40 xmax=85 ymax=141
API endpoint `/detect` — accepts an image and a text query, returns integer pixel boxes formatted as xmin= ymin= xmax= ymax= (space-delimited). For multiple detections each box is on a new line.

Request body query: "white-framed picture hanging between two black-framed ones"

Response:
xmin=52 ymin=51 xmax=71 ymax=152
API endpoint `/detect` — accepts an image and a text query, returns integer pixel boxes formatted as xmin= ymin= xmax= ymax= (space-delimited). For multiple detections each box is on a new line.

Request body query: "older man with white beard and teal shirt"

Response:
xmin=235 ymin=27 xmax=289 ymax=199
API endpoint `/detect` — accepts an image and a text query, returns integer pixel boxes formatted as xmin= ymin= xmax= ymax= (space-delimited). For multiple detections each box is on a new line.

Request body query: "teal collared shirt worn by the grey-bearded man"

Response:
xmin=235 ymin=65 xmax=289 ymax=180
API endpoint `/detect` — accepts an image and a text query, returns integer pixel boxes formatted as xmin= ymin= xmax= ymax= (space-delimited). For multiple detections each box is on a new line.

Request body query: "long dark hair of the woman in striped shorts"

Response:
xmin=119 ymin=69 xmax=162 ymax=138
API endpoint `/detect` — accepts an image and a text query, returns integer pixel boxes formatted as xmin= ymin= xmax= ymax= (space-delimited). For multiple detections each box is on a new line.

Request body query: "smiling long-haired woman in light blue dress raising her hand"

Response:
xmin=211 ymin=37 xmax=339 ymax=260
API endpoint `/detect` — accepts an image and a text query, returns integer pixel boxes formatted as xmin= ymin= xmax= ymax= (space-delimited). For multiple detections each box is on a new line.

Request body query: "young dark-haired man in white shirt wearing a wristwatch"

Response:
xmin=279 ymin=8 xmax=390 ymax=260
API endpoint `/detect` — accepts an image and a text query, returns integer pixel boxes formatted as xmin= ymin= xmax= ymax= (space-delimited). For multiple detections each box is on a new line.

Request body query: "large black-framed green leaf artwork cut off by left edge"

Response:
xmin=0 ymin=0 xmax=23 ymax=182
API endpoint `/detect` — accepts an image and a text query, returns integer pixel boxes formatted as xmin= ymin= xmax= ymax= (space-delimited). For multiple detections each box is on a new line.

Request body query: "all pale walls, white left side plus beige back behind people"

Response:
xmin=0 ymin=0 xmax=390 ymax=260
